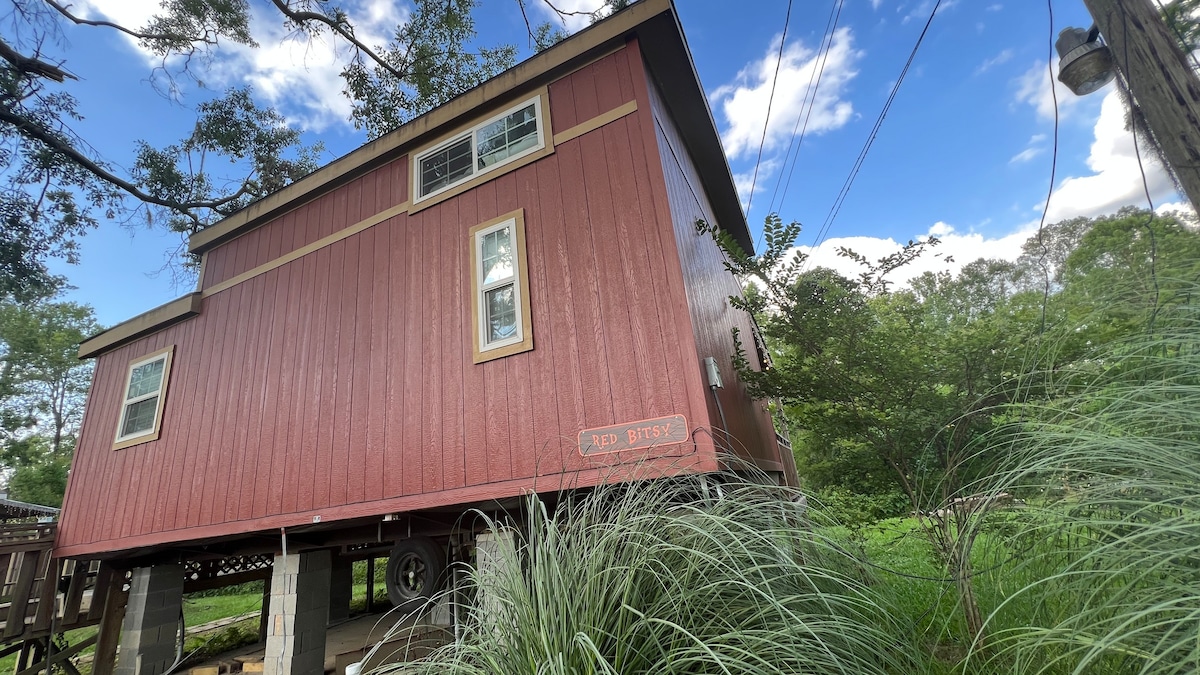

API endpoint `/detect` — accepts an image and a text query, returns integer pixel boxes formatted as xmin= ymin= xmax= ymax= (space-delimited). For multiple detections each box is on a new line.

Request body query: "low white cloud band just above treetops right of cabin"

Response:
xmin=798 ymin=221 xmax=1037 ymax=287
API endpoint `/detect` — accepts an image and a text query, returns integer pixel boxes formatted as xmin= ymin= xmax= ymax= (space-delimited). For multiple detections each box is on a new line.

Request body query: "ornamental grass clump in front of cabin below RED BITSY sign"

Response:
xmin=374 ymin=468 xmax=920 ymax=675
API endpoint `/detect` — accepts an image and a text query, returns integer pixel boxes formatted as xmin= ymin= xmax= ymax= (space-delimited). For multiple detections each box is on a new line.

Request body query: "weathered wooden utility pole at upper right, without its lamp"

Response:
xmin=1084 ymin=0 xmax=1200 ymax=213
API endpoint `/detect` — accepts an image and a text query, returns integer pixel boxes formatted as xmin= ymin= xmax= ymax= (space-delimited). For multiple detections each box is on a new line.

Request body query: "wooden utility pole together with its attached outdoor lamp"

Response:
xmin=1075 ymin=0 xmax=1200 ymax=211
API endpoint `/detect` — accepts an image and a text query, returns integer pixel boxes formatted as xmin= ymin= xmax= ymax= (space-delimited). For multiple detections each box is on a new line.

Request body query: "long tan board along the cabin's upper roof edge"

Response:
xmin=188 ymin=0 xmax=677 ymax=253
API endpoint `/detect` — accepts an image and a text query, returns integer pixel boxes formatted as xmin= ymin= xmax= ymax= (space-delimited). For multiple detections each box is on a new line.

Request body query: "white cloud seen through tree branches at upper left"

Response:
xmin=75 ymin=0 xmax=408 ymax=131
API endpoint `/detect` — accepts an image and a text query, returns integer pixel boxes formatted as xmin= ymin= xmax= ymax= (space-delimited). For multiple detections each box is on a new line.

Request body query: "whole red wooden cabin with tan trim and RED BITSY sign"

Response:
xmin=56 ymin=0 xmax=794 ymax=667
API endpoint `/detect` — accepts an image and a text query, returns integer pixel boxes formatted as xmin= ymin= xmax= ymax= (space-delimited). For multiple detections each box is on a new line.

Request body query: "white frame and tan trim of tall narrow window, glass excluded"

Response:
xmin=470 ymin=210 xmax=533 ymax=363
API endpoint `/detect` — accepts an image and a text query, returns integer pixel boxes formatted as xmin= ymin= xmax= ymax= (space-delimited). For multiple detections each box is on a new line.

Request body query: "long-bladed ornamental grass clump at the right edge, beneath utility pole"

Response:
xmin=968 ymin=307 xmax=1200 ymax=674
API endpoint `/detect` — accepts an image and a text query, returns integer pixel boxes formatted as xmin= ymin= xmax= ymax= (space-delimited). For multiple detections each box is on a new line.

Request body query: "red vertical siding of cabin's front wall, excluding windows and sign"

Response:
xmin=60 ymin=48 xmax=730 ymax=555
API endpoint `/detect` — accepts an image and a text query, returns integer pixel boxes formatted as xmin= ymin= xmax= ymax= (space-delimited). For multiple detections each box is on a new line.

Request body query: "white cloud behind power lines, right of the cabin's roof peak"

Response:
xmin=710 ymin=28 xmax=863 ymax=157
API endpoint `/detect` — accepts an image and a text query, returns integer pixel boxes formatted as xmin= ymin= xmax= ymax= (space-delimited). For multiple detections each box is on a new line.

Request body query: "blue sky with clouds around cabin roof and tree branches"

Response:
xmin=44 ymin=0 xmax=1180 ymax=324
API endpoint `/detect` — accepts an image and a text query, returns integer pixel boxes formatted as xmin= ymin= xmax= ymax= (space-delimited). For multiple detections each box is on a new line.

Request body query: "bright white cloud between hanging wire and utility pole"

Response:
xmin=1036 ymin=91 xmax=1175 ymax=222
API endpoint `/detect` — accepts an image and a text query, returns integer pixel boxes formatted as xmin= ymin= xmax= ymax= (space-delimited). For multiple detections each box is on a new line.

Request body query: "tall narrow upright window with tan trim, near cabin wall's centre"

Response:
xmin=470 ymin=210 xmax=533 ymax=363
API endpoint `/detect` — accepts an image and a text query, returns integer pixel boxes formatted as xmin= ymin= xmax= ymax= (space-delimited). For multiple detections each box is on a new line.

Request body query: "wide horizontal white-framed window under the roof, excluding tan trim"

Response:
xmin=413 ymin=96 xmax=546 ymax=203
